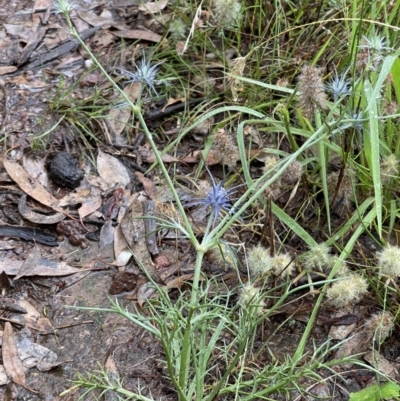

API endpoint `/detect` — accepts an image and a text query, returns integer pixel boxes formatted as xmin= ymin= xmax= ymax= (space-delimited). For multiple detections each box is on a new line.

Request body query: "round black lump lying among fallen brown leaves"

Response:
xmin=50 ymin=152 xmax=83 ymax=189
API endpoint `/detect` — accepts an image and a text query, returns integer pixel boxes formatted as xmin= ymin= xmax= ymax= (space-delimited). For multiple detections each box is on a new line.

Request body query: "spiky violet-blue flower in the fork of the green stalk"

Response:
xmin=185 ymin=166 xmax=241 ymax=226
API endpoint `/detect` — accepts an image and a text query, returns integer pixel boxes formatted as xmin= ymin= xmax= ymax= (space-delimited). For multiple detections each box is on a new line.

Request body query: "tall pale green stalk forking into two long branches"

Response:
xmin=60 ymin=0 xmax=338 ymax=401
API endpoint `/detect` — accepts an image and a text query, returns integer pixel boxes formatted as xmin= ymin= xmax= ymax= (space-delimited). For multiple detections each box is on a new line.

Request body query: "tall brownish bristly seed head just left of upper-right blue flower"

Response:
xmin=298 ymin=65 xmax=327 ymax=121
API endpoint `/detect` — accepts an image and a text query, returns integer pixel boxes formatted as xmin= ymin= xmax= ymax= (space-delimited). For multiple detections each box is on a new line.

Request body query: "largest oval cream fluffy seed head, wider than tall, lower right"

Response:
xmin=326 ymin=273 xmax=368 ymax=308
